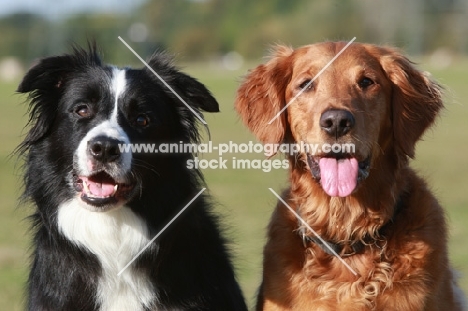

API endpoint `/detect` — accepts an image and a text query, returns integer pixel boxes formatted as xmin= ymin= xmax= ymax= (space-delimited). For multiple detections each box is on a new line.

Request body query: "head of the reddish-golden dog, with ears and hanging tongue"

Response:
xmin=235 ymin=42 xmax=443 ymax=197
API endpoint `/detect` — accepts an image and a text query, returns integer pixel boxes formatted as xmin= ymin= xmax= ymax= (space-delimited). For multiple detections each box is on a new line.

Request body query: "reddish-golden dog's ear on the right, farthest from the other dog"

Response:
xmin=381 ymin=49 xmax=443 ymax=158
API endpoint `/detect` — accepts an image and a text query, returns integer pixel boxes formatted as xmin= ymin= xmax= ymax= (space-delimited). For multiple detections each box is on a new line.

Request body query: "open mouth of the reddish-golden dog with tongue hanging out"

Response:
xmin=307 ymin=154 xmax=370 ymax=197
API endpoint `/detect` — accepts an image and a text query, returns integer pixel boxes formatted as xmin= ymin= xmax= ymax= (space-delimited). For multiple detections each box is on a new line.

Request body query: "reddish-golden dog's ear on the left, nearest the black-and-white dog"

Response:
xmin=235 ymin=46 xmax=293 ymax=143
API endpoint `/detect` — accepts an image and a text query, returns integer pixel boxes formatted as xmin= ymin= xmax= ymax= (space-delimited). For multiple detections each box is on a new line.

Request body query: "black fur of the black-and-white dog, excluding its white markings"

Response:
xmin=18 ymin=45 xmax=246 ymax=311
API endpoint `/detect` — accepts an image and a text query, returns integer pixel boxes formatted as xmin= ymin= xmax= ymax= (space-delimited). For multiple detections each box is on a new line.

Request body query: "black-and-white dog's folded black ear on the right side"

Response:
xmin=148 ymin=52 xmax=219 ymax=112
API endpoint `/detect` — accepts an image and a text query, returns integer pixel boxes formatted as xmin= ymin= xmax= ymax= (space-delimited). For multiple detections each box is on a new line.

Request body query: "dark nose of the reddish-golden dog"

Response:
xmin=320 ymin=109 xmax=355 ymax=138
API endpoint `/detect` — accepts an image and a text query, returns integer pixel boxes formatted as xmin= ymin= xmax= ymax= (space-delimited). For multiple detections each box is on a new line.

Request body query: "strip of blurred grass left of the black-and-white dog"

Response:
xmin=0 ymin=84 xmax=29 ymax=310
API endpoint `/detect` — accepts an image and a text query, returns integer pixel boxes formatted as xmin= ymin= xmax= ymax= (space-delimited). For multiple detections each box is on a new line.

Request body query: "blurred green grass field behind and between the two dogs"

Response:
xmin=0 ymin=61 xmax=468 ymax=310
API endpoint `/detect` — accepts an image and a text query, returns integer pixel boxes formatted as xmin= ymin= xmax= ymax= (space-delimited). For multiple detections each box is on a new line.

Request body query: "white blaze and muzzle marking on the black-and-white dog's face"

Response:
xmin=75 ymin=68 xmax=132 ymax=176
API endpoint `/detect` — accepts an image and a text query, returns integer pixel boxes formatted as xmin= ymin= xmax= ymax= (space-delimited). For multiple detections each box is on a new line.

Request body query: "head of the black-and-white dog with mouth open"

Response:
xmin=18 ymin=45 xmax=218 ymax=211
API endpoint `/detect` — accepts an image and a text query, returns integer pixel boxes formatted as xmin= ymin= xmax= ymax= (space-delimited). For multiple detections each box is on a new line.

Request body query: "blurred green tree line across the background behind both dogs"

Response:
xmin=0 ymin=0 xmax=468 ymax=62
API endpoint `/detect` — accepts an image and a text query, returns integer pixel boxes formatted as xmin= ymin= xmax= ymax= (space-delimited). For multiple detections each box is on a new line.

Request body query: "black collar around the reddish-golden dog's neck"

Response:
xmin=298 ymin=192 xmax=406 ymax=257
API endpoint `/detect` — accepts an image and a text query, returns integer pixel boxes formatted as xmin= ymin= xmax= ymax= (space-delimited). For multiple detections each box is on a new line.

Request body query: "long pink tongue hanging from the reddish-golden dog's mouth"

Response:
xmin=319 ymin=158 xmax=359 ymax=197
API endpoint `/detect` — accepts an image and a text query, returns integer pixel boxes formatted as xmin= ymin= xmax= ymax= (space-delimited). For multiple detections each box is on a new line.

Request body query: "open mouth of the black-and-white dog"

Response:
xmin=74 ymin=171 xmax=133 ymax=207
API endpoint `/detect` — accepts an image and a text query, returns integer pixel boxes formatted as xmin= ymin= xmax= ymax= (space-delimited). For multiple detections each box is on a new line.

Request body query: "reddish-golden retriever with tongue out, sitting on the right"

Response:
xmin=235 ymin=42 xmax=464 ymax=311
